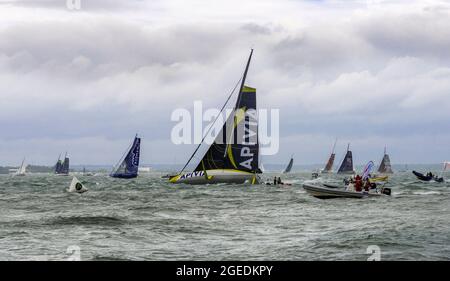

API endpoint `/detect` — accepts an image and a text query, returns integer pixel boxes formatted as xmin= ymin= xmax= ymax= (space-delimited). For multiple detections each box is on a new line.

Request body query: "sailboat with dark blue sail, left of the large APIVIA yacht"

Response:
xmin=109 ymin=134 xmax=141 ymax=179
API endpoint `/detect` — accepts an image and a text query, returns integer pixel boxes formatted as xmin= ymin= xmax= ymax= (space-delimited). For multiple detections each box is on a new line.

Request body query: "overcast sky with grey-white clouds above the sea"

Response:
xmin=0 ymin=0 xmax=450 ymax=165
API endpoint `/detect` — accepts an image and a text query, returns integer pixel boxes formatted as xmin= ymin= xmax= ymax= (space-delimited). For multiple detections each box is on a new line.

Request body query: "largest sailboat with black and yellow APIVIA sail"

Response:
xmin=169 ymin=49 xmax=261 ymax=184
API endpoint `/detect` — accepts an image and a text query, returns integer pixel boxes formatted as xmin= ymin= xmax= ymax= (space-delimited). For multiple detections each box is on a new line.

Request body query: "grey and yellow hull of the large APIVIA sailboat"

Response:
xmin=169 ymin=170 xmax=255 ymax=184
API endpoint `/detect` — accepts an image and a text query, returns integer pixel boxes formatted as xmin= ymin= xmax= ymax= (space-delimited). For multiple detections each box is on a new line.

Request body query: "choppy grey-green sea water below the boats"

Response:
xmin=0 ymin=172 xmax=450 ymax=260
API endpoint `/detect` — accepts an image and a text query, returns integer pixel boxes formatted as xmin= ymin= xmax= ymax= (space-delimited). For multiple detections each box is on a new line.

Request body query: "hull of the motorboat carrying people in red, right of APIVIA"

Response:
xmin=303 ymin=184 xmax=385 ymax=199
